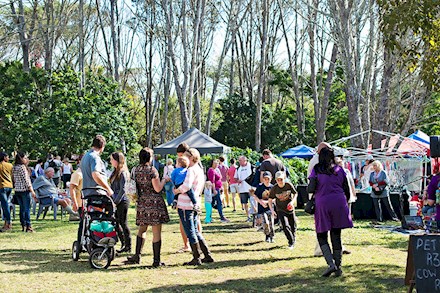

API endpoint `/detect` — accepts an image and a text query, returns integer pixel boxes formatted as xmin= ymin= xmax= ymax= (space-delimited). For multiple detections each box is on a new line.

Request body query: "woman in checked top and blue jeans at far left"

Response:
xmin=12 ymin=152 xmax=37 ymax=232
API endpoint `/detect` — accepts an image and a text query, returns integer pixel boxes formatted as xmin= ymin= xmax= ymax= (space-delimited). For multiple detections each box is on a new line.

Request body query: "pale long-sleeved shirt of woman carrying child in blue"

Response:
xmin=177 ymin=164 xmax=205 ymax=210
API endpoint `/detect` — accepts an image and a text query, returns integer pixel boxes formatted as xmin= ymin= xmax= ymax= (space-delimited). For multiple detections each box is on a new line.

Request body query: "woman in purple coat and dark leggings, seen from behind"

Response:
xmin=308 ymin=148 xmax=353 ymax=277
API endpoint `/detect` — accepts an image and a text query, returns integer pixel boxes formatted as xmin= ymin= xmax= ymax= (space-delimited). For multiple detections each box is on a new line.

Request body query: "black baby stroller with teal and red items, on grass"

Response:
xmin=72 ymin=194 xmax=118 ymax=269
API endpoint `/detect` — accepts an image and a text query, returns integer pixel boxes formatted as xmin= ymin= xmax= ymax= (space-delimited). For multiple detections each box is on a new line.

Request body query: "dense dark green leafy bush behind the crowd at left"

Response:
xmin=0 ymin=62 xmax=137 ymax=158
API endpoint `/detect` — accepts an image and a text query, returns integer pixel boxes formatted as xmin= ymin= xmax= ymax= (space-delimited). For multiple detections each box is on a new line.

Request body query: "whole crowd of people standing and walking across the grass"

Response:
xmin=0 ymin=135 xmax=372 ymax=276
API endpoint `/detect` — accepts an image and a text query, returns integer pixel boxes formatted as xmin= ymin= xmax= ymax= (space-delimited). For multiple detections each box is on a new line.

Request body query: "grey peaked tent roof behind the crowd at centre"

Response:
xmin=154 ymin=128 xmax=231 ymax=155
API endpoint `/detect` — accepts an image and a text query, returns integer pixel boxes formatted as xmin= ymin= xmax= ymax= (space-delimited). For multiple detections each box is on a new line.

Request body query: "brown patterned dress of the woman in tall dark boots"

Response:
xmin=134 ymin=165 xmax=170 ymax=226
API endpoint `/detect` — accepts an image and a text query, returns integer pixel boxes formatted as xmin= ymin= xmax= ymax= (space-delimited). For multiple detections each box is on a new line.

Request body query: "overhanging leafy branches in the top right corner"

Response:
xmin=378 ymin=0 xmax=440 ymax=90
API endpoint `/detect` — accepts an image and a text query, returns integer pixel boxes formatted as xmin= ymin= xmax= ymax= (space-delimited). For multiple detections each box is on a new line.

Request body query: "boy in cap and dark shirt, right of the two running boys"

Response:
xmin=269 ymin=171 xmax=297 ymax=249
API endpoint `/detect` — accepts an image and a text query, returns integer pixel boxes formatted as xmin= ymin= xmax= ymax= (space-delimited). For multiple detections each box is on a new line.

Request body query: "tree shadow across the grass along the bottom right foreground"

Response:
xmin=133 ymin=263 xmax=403 ymax=293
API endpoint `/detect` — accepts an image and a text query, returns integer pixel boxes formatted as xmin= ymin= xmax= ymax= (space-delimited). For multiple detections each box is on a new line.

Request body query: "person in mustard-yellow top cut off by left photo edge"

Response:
xmin=0 ymin=152 xmax=13 ymax=232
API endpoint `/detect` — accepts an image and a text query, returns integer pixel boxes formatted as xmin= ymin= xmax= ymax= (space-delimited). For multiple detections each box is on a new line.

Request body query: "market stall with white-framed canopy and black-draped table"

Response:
xmin=331 ymin=130 xmax=430 ymax=219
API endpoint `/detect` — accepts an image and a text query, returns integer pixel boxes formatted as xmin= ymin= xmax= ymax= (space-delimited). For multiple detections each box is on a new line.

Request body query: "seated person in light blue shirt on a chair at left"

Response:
xmin=32 ymin=167 xmax=78 ymax=216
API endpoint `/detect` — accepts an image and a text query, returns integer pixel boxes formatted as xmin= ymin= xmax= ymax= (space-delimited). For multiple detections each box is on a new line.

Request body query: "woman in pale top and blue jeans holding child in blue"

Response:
xmin=174 ymin=148 xmax=214 ymax=265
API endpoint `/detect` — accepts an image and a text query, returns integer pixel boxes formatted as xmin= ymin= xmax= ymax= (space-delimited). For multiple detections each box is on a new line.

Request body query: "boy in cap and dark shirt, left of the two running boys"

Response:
xmin=251 ymin=171 xmax=275 ymax=243
